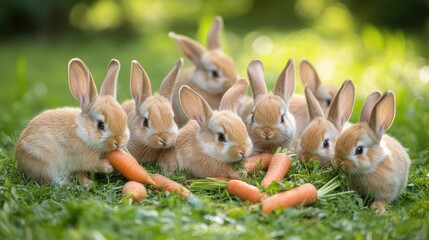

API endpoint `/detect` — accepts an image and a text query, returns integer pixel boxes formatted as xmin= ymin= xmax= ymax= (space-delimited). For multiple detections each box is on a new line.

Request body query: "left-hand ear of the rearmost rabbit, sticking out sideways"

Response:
xmin=168 ymin=32 xmax=206 ymax=65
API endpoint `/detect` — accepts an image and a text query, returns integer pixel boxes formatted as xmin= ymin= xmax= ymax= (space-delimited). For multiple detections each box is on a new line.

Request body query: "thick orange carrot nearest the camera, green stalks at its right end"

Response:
xmin=262 ymin=183 xmax=317 ymax=214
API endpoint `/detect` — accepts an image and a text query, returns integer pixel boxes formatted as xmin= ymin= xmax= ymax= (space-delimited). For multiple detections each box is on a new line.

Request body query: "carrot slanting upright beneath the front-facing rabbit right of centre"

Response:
xmin=261 ymin=153 xmax=292 ymax=187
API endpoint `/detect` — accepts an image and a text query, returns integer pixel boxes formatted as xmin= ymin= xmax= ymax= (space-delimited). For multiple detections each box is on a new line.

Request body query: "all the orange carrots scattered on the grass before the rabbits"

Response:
xmin=106 ymin=150 xmax=339 ymax=214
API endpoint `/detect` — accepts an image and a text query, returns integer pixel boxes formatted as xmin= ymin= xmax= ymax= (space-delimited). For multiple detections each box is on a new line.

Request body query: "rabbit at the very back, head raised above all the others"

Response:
xmin=169 ymin=16 xmax=238 ymax=127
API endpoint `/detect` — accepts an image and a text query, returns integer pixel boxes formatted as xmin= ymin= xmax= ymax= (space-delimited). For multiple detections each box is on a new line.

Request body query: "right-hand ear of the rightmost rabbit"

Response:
xmin=369 ymin=91 xmax=396 ymax=140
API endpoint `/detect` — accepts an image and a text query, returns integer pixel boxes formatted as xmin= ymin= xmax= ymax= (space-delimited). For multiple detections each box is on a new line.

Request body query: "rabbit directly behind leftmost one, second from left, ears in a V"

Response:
xmin=122 ymin=58 xmax=183 ymax=163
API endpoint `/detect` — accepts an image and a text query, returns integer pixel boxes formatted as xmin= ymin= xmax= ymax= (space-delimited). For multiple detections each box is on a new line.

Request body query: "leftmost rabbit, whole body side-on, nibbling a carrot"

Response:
xmin=15 ymin=58 xmax=130 ymax=187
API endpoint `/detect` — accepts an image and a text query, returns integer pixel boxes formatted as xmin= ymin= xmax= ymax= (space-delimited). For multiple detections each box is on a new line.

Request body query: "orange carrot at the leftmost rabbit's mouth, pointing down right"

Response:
xmin=105 ymin=149 xmax=156 ymax=185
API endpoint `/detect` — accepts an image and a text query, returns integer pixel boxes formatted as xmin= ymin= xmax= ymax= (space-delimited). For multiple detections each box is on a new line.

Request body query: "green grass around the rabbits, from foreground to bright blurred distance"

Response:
xmin=0 ymin=13 xmax=429 ymax=239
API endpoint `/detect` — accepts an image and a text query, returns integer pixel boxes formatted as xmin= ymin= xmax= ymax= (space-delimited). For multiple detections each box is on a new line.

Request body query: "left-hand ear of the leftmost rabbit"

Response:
xmin=68 ymin=58 xmax=98 ymax=112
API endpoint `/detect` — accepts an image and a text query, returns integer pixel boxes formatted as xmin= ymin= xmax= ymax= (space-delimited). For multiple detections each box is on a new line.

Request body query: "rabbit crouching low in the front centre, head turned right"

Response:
xmin=160 ymin=79 xmax=253 ymax=178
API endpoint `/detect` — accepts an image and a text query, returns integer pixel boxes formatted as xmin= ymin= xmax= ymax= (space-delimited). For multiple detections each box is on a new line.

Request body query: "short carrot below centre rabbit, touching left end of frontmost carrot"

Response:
xmin=226 ymin=180 xmax=266 ymax=203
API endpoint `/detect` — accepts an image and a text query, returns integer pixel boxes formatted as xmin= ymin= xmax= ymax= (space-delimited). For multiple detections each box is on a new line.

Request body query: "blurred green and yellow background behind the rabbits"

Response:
xmin=0 ymin=0 xmax=429 ymax=155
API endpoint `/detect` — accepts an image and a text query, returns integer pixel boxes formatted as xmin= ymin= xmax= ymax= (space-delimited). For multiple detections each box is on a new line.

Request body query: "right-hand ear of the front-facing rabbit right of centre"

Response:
xmin=274 ymin=59 xmax=295 ymax=103
